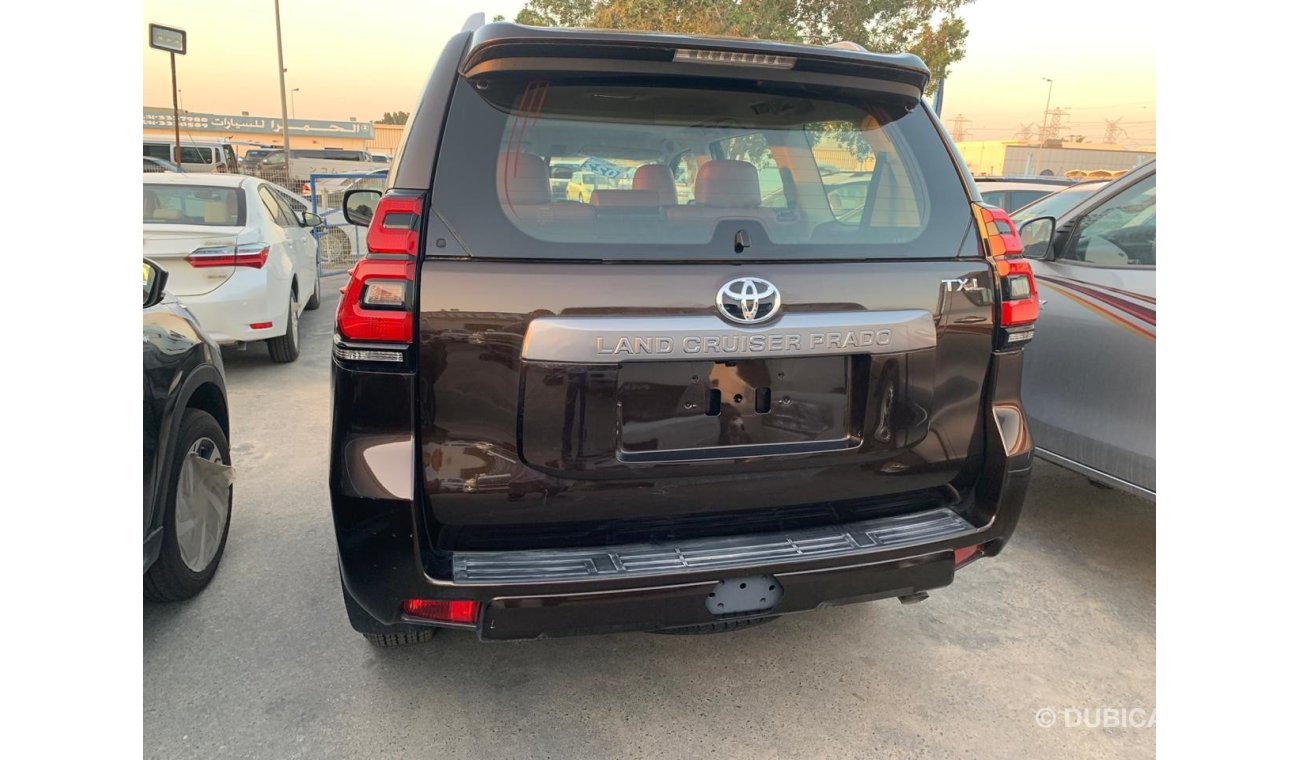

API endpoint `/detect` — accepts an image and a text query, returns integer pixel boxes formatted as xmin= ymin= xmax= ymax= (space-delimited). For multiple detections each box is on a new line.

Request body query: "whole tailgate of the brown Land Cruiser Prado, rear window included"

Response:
xmin=410 ymin=39 xmax=995 ymax=540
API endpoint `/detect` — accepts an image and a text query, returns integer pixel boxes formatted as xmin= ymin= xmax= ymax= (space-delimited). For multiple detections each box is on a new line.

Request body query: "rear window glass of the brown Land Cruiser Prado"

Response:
xmin=434 ymin=73 xmax=970 ymax=259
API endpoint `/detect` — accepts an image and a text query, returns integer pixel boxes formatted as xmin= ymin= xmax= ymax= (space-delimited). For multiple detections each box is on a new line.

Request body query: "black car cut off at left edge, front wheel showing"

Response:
xmin=144 ymin=259 xmax=233 ymax=602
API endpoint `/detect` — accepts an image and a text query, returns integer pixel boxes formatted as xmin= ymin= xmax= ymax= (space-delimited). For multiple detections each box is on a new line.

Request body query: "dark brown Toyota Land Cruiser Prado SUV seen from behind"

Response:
xmin=329 ymin=23 xmax=1037 ymax=646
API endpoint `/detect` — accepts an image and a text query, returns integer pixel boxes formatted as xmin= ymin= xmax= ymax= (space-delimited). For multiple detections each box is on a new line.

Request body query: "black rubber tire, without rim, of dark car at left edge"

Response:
xmin=144 ymin=409 xmax=234 ymax=602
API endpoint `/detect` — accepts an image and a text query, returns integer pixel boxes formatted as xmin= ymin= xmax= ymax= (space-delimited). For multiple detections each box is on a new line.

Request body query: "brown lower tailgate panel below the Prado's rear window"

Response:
xmin=419 ymin=261 xmax=992 ymax=525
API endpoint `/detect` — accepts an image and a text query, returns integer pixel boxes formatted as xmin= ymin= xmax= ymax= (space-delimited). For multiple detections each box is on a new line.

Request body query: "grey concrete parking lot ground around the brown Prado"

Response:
xmin=144 ymin=285 xmax=1156 ymax=759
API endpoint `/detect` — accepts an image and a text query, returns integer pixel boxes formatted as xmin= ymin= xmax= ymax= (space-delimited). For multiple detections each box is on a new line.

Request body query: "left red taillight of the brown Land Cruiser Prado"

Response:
xmin=335 ymin=195 xmax=424 ymax=353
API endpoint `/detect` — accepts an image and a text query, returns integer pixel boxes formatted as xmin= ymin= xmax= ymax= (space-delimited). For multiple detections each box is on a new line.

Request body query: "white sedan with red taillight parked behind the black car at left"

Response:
xmin=144 ymin=174 xmax=321 ymax=361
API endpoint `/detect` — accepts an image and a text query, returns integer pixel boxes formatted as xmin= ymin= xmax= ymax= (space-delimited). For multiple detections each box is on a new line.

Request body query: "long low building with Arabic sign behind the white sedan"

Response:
xmin=143 ymin=108 xmax=406 ymax=157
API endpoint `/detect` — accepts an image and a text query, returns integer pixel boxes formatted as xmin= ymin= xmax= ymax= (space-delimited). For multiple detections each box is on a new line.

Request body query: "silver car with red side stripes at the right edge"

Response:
xmin=1021 ymin=161 xmax=1156 ymax=500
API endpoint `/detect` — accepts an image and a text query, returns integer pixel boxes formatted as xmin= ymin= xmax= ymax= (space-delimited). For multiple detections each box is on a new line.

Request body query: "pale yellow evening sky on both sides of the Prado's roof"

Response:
xmin=140 ymin=0 xmax=1158 ymax=147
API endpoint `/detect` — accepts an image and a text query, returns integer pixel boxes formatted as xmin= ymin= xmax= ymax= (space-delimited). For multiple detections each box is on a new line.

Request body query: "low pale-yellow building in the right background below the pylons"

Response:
xmin=957 ymin=140 xmax=1156 ymax=177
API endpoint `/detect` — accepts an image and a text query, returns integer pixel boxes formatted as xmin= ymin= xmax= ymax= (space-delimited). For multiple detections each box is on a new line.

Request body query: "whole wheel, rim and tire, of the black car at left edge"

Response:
xmin=144 ymin=409 xmax=234 ymax=602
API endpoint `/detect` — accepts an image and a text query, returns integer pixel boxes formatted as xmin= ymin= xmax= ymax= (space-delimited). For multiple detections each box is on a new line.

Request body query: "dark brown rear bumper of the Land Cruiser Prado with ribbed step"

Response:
xmin=330 ymin=352 xmax=1032 ymax=639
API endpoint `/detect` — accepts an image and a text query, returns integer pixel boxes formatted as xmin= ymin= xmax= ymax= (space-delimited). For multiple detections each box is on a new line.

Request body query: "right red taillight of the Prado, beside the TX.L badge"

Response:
xmin=971 ymin=203 xmax=1039 ymax=348
